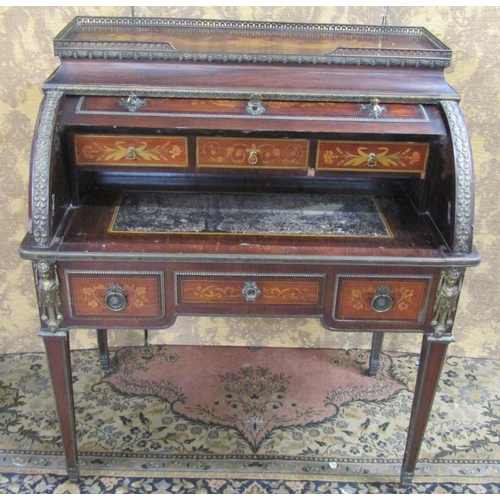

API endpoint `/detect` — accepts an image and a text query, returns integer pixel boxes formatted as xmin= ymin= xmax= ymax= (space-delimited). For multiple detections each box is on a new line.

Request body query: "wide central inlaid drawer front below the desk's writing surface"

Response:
xmin=176 ymin=273 xmax=324 ymax=306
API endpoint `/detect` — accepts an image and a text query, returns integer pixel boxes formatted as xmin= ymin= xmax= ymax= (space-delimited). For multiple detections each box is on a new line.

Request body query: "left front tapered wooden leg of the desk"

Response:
xmin=39 ymin=330 xmax=79 ymax=483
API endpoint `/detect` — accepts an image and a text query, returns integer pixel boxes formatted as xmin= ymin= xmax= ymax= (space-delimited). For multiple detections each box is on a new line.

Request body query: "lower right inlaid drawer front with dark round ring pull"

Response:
xmin=334 ymin=275 xmax=432 ymax=322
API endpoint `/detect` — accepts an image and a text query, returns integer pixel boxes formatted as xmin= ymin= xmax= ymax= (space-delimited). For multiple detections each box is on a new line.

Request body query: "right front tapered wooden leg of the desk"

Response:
xmin=401 ymin=335 xmax=454 ymax=486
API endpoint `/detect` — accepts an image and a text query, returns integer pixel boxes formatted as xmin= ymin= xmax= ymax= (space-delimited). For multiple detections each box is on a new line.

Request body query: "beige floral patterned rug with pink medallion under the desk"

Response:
xmin=0 ymin=346 xmax=500 ymax=493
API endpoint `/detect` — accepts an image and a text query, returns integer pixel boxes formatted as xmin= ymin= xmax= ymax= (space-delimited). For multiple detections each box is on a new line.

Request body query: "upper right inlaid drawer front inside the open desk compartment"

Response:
xmin=316 ymin=141 xmax=429 ymax=173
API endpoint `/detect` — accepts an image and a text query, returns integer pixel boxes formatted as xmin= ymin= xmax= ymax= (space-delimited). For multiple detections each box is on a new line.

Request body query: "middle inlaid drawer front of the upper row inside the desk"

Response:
xmin=196 ymin=137 xmax=309 ymax=170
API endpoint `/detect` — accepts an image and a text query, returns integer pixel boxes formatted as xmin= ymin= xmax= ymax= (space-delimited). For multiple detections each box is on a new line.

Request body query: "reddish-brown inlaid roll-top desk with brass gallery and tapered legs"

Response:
xmin=20 ymin=17 xmax=479 ymax=484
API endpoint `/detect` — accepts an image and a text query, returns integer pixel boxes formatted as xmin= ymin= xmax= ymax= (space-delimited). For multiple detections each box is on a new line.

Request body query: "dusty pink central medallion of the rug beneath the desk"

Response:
xmin=103 ymin=346 xmax=406 ymax=454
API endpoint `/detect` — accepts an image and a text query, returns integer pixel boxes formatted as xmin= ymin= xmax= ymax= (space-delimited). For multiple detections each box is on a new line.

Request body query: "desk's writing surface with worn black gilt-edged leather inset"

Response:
xmin=44 ymin=186 xmax=443 ymax=260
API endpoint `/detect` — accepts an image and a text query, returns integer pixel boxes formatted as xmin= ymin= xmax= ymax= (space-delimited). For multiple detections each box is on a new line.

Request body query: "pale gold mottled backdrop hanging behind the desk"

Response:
xmin=0 ymin=6 xmax=500 ymax=359
